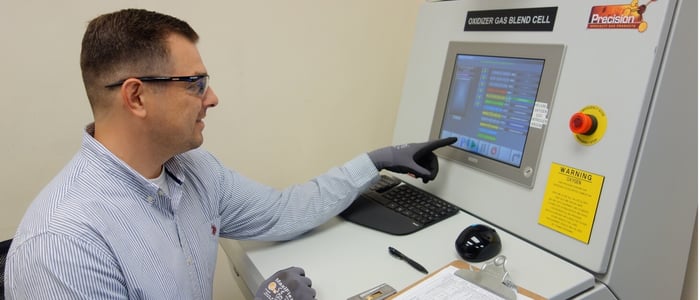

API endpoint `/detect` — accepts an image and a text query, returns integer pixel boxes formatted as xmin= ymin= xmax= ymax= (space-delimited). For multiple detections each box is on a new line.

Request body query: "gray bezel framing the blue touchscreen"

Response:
xmin=430 ymin=41 xmax=565 ymax=188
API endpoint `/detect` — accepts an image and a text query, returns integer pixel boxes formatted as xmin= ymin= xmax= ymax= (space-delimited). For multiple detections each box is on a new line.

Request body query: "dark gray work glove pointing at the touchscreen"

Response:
xmin=368 ymin=137 xmax=457 ymax=183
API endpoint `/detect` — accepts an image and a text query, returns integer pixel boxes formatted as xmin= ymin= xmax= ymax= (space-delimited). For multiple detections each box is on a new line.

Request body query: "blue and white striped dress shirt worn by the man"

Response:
xmin=5 ymin=127 xmax=378 ymax=299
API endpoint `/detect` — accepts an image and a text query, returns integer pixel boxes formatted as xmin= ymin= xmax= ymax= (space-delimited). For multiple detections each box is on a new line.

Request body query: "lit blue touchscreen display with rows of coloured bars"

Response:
xmin=440 ymin=54 xmax=544 ymax=167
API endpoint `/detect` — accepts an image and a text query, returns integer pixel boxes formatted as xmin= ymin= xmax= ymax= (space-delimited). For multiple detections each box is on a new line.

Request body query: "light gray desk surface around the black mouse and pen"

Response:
xmin=221 ymin=212 xmax=594 ymax=299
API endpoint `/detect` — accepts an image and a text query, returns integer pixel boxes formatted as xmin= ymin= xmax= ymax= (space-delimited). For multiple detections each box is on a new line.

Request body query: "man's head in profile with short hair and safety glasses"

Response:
xmin=80 ymin=9 xmax=218 ymax=169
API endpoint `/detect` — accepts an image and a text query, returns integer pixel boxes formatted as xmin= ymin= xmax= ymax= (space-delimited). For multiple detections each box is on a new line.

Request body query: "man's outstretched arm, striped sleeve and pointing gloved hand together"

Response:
xmin=210 ymin=138 xmax=456 ymax=241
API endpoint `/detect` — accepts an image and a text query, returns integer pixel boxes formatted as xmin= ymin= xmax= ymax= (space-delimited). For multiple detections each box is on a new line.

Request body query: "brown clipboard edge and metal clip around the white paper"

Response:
xmin=388 ymin=260 xmax=546 ymax=300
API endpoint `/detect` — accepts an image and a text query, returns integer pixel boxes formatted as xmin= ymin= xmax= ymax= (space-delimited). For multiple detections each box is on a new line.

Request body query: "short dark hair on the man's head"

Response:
xmin=80 ymin=8 xmax=199 ymax=111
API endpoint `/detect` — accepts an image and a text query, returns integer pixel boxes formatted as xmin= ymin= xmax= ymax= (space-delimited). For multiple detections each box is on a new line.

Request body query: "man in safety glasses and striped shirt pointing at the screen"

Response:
xmin=5 ymin=9 xmax=454 ymax=299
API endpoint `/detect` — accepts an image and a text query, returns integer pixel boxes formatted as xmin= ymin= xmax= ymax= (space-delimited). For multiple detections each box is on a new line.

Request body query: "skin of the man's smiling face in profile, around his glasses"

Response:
xmin=148 ymin=35 xmax=219 ymax=155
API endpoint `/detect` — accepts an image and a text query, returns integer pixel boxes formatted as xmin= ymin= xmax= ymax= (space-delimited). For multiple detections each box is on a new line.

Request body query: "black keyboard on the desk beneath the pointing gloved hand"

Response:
xmin=340 ymin=175 xmax=459 ymax=235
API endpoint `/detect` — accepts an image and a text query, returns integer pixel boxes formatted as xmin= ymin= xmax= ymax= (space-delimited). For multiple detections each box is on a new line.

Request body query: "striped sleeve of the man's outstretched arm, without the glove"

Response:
xmin=216 ymin=154 xmax=379 ymax=241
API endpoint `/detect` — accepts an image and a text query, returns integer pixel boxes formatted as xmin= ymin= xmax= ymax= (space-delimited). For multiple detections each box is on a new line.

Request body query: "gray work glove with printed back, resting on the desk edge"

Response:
xmin=255 ymin=267 xmax=316 ymax=300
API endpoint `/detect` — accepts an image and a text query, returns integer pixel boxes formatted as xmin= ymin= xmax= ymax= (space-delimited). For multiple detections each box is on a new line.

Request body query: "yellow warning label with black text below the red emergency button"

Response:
xmin=538 ymin=163 xmax=605 ymax=244
